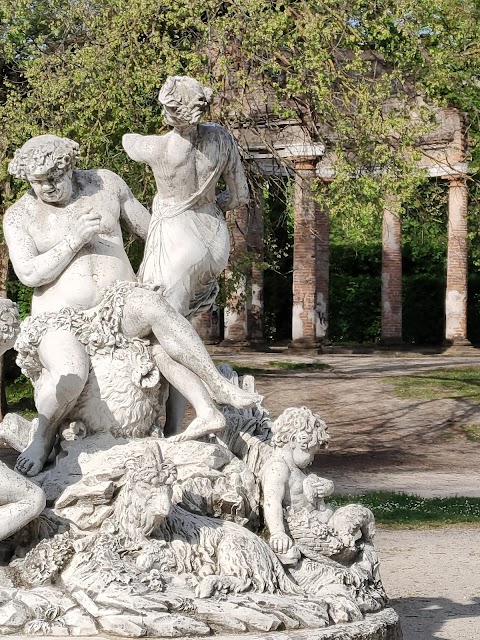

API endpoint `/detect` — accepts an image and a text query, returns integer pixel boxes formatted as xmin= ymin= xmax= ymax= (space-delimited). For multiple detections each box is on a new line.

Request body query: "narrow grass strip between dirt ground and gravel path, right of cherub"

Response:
xmin=330 ymin=491 xmax=480 ymax=528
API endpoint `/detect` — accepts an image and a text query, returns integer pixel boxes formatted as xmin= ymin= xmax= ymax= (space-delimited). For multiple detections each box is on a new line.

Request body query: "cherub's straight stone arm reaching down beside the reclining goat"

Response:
xmin=262 ymin=460 xmax=292 ymax=553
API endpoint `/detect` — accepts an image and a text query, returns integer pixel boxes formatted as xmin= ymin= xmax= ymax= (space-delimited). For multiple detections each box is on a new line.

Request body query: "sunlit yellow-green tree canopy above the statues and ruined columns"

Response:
xmin=0 ymin=0 xmax=480 ymax=215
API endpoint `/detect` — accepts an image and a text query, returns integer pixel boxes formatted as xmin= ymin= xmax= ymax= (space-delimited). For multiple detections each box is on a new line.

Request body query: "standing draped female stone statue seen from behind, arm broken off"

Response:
xmin=123 ymin=76 xmax=249 ymax=435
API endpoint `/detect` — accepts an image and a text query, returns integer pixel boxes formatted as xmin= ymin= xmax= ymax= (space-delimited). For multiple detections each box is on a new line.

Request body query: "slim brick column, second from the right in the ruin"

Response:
xmin=381 ymin=200 xmax=402 ymax=344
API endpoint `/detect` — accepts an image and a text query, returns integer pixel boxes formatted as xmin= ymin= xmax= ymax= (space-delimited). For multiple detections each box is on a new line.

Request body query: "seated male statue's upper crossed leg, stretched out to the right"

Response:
xmin=122 ymin=289 xmax=262 ymax=409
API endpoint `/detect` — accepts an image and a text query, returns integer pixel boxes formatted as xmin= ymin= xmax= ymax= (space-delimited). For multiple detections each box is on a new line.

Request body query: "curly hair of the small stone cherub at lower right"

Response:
xmin=272 ymin=407 xmax=330 ymax=449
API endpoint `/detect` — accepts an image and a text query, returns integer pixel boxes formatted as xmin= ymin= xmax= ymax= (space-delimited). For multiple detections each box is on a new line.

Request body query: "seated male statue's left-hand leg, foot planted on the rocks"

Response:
xmin=15 ymin=330 xmax=89 ymax=476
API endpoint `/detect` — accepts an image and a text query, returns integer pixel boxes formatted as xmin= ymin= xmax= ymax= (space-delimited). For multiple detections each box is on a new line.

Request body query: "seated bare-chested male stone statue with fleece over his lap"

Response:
xmin=4 ymin=135 xmax=260 ymax=476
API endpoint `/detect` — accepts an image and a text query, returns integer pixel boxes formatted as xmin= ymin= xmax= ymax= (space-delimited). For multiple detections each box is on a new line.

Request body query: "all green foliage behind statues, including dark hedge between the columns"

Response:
xmin=0 ymin=0 xmax=480 ymax=341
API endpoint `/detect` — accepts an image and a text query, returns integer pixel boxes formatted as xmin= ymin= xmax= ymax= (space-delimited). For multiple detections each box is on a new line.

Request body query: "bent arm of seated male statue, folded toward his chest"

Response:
xmin=3 ymin=211 xmax=85 ymax=287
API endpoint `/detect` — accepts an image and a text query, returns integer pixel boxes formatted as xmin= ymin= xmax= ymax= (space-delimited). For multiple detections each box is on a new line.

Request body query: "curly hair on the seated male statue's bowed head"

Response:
xmin=8 ymin=135 xmax=80 ymax=180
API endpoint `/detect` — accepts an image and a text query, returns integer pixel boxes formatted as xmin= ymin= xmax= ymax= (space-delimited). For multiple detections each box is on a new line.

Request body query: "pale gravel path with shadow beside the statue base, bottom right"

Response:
xmin=376 ymin=527 xmax=480 ymax=640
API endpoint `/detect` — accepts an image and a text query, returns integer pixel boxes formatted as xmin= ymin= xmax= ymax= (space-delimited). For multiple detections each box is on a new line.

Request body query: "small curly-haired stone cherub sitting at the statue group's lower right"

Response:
xmin=261 ymin=407 xmax=386 ymax=611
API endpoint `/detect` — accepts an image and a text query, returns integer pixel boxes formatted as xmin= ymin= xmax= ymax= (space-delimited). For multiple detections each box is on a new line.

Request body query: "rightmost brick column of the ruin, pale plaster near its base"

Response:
xmin=445 ymin=176 xmax=470 ymax=345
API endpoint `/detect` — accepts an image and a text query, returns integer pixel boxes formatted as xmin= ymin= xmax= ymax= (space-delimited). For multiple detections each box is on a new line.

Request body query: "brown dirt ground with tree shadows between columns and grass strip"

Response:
xmin=221 ymin=349 xmax=480 ymax=497
